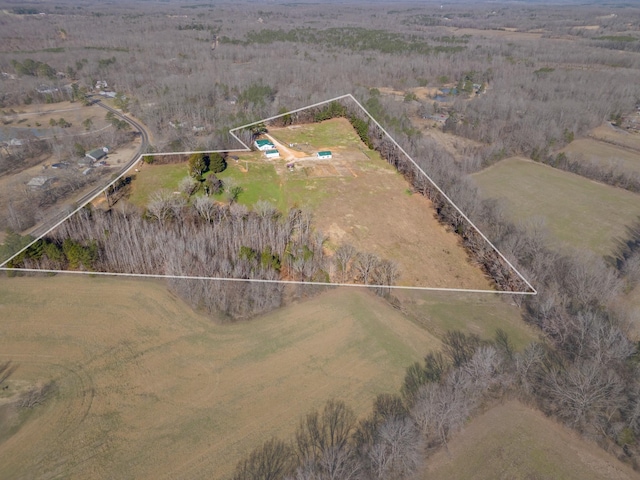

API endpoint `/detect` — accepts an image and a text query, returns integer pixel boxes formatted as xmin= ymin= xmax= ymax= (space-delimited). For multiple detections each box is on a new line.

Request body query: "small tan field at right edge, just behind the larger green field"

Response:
xmin=562 ymin=138 xmax=640 ymax=173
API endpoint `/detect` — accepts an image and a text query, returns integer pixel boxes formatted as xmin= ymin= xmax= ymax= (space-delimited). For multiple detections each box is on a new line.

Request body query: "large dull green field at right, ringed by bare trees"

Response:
xmin=473 ymin=158 xmax=640 ymax=255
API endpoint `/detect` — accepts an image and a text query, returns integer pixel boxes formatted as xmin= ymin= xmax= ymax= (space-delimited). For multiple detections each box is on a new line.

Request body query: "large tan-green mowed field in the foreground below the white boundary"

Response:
xmin=0 ymin=275 xmax=439 ymax=479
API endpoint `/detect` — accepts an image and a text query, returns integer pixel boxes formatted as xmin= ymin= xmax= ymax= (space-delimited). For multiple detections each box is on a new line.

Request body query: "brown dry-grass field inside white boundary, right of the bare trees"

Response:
xmin=270 ymin=118 xmax=492 ymax=290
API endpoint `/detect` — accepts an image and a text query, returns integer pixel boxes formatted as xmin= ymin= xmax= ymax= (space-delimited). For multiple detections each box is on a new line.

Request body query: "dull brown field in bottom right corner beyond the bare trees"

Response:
xmin=422 ymin=401 xmax=640 ymax=480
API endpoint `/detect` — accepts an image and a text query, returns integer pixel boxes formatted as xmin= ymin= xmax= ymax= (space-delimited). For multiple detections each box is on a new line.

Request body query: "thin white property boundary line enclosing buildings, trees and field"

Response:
xmin=0 ymin=93 xmax=538 ymax=295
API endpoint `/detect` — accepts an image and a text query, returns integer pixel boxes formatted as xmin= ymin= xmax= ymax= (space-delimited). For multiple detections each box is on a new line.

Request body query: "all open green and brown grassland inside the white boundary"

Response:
xmin=129 ymin=118 xmax=492 ymax=290
